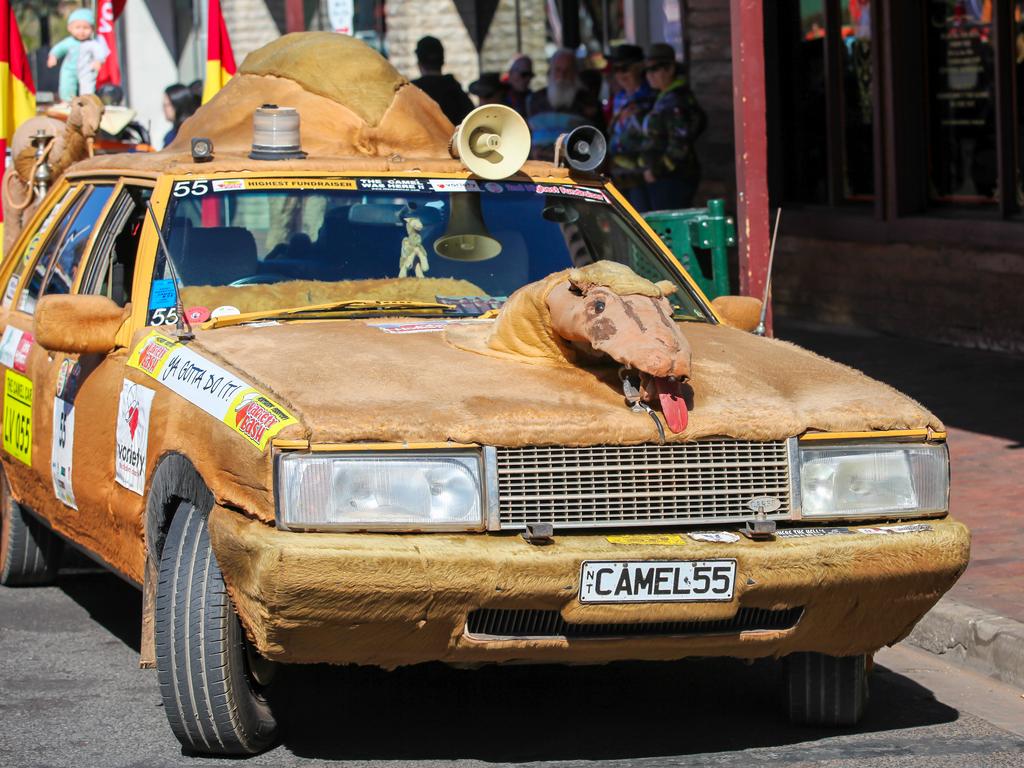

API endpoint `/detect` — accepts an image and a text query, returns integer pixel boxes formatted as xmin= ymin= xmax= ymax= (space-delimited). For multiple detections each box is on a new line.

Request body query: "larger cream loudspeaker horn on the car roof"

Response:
xmin=449 ymin=104 xmax=530 ymax=179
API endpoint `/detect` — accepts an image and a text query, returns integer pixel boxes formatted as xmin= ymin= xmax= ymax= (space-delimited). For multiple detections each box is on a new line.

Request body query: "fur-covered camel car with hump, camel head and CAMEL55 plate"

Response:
xmin=0 ymin=33 xmax=970 ymax=755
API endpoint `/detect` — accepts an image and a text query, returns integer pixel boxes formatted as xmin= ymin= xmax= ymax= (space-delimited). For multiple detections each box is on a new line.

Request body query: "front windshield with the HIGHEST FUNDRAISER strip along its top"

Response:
xmin=150 ymin=177 xmax=707 ymax=325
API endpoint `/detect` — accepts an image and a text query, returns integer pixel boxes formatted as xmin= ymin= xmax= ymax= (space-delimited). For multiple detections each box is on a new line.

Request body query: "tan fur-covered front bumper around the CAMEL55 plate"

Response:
xmin=210 ymin=507 xmax=970 ymax=668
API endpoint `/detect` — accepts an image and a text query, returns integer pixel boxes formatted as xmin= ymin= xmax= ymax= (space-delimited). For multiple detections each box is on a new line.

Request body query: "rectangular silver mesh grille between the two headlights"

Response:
xmin=493 ymin=439 xmax=796 ymax=530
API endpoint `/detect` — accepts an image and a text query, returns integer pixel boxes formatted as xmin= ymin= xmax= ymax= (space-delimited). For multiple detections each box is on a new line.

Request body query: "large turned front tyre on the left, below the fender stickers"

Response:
xmin=156 ymin=502 xmax=278 ymax=755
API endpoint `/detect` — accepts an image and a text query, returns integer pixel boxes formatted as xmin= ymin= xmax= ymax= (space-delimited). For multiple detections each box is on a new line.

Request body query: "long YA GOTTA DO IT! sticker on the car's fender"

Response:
xmin=128 ymin=332 xmax=296 ymax=451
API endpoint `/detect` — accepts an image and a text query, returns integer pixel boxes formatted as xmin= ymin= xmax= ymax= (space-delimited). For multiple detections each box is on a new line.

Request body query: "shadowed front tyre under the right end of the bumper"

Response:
xmin=785 ymin=653 xmax=867 ymax=726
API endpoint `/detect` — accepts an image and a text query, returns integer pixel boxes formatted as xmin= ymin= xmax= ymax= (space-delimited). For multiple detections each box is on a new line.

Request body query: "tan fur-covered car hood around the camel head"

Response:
xmin=180 ymin=317 xmax=942 ymax=468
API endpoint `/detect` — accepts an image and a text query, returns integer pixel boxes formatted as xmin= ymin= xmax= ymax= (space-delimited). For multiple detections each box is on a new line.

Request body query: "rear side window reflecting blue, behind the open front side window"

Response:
xmin=17 ymin=185 xmax=114 ymax=314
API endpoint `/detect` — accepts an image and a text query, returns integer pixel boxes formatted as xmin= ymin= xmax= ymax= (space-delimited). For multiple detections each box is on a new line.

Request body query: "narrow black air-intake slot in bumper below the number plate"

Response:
xmin=466 ymin=607 xmax=804 ymax=638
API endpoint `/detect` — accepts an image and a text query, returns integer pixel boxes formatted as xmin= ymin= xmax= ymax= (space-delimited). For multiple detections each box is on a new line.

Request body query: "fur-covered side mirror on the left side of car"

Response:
xmin=32 ymin=295 xmax=131 ymax=354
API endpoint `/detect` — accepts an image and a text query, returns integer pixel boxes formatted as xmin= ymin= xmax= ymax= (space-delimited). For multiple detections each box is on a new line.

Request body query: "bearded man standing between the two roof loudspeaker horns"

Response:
xmin=526 ymin=48 xmax=604 ymax=160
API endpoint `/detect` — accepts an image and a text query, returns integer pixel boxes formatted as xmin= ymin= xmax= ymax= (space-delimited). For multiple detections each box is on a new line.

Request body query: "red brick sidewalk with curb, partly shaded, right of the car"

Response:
xmin=776 ymin=319 xmax=1024 ymax=687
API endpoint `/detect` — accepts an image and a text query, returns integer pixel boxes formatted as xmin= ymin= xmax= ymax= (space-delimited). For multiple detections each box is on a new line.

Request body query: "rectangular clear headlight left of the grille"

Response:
xmin=278 ymin=452 xmax=483 ymax=530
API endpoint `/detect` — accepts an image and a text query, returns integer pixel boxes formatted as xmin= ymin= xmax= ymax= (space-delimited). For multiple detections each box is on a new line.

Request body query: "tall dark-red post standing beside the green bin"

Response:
xmin=729 ymin=0 xmax=771 ymax=336
